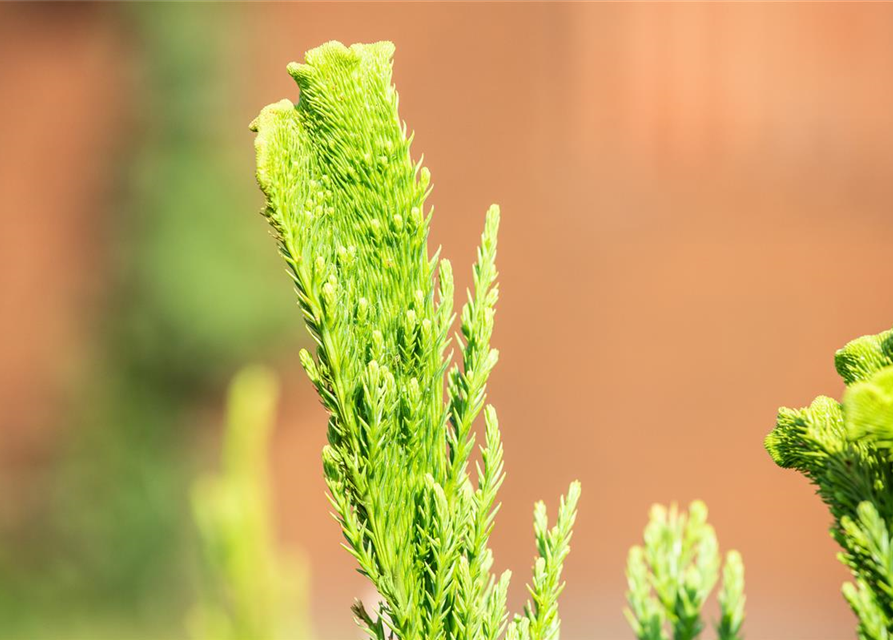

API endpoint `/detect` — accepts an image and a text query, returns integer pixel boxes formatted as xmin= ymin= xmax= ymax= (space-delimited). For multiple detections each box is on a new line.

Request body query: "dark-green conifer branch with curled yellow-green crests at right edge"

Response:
xmin=766 ymin=331 xmax=893 ymax=640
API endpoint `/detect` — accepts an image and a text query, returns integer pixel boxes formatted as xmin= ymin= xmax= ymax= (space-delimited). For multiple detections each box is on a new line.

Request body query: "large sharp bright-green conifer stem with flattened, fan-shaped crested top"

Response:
xmin=252 ymin=42 xmax=580 ymax=640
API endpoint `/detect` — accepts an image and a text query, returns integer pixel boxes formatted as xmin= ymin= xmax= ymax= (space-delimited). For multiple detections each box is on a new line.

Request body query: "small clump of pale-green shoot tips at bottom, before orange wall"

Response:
xmin=624 ymin=501 xmax=744 ymax=640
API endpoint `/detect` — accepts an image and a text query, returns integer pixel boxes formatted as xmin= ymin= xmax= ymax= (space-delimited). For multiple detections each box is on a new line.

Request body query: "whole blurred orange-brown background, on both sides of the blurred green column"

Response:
xmin=0 ymin=2 xmax=893 ymax=640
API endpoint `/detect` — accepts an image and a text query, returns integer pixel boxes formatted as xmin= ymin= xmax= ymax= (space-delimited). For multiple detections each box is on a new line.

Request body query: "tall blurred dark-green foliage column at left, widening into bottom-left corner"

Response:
xmin=0 ymin=3 xmax=296 ymax=640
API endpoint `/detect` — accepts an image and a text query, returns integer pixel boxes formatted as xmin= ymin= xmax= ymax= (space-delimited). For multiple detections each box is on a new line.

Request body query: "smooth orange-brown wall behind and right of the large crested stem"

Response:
xmin=0 ymin=3 xmax=893 ymax=640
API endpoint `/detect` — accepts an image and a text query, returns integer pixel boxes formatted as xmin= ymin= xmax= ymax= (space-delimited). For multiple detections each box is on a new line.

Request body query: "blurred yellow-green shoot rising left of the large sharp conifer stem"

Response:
xmin=192 ymin=367 xmax=310 ymax=640
